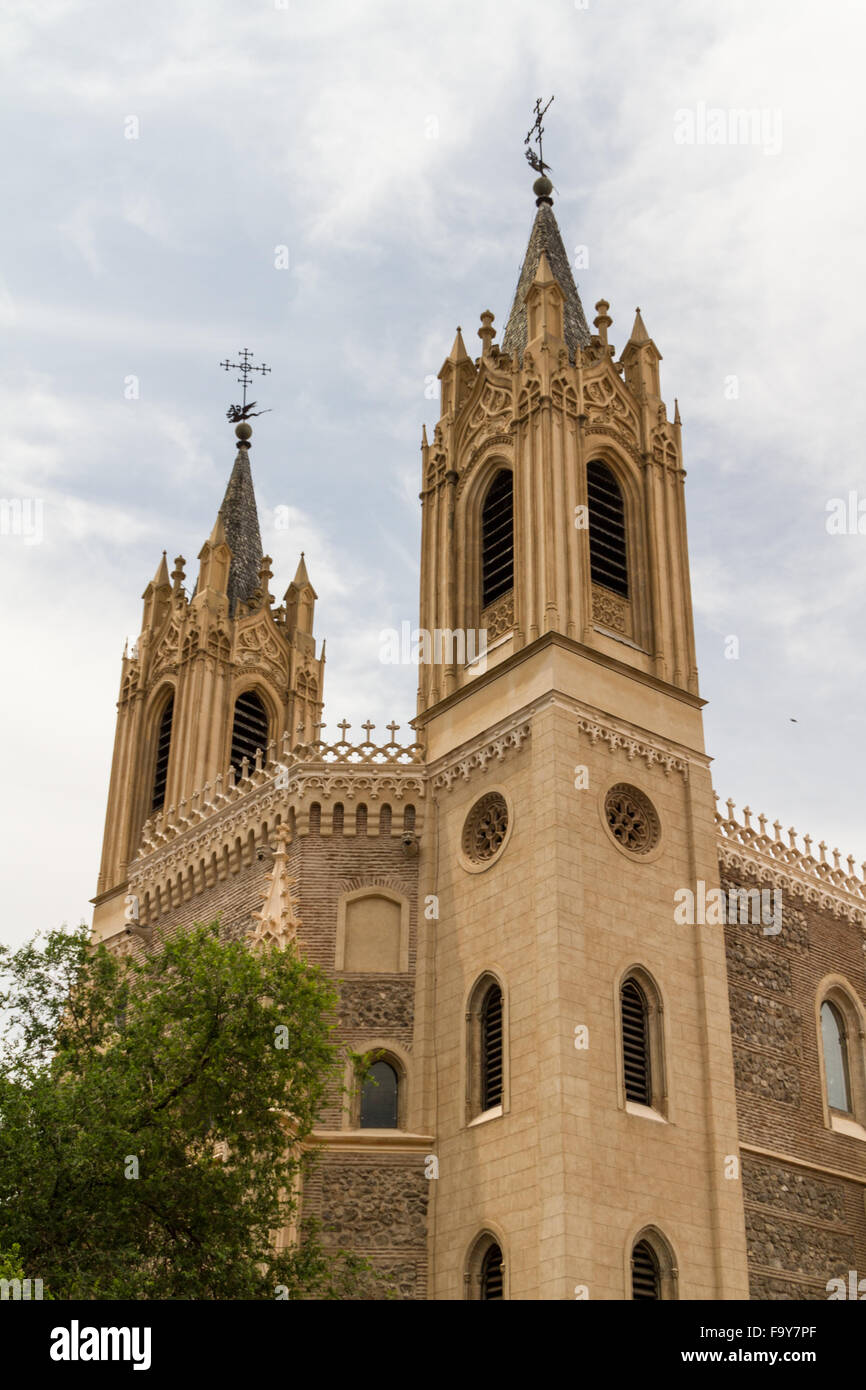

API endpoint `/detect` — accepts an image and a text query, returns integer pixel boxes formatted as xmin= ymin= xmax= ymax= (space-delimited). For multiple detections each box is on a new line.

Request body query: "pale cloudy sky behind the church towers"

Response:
xmin=0 ymin=0 xmax=866 ymax=956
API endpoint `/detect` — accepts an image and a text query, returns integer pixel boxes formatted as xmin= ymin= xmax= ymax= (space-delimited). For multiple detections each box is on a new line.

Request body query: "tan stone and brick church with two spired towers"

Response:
xmin=93 ymin=165 xmax=866 ymax=1300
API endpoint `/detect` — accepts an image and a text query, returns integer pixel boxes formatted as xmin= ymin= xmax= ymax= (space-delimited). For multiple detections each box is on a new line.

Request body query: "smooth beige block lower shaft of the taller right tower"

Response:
xmin=431 ymin=696 xmax=746 ymax=1300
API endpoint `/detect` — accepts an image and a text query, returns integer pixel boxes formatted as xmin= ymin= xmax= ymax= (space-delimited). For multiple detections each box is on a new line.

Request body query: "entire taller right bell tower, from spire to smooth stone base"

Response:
xmin=416 ymin=149 xmax=746 ymax=1300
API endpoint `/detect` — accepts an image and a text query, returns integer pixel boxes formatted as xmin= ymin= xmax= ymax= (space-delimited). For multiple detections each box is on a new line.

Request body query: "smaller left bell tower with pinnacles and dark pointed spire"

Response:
xmin=93 ymin=417 xmax=325 ymax=941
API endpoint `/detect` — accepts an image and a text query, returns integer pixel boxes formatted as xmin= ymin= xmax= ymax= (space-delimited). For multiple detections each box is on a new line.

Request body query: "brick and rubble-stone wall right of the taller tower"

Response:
xmin=721 ymin=869 xmax=866 ymax=1300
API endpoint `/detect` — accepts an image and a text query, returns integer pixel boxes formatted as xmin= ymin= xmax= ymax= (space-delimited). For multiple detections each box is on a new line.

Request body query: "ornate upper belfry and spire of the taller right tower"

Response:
xmin=418 ymin=214 xmax=698 ymax=713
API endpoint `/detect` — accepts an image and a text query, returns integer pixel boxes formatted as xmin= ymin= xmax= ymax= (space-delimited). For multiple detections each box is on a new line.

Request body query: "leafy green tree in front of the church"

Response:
xmin=0 ymin=923 xmax=369 ymax=1298
